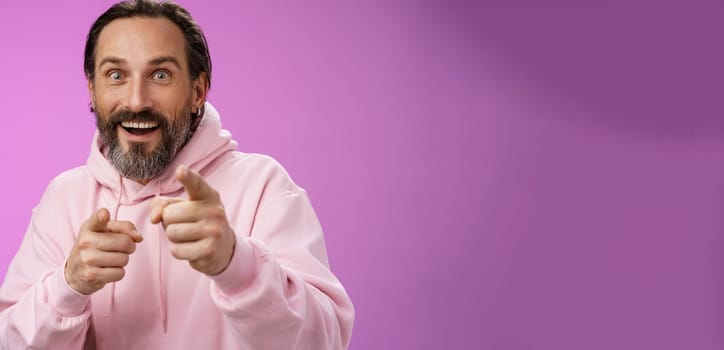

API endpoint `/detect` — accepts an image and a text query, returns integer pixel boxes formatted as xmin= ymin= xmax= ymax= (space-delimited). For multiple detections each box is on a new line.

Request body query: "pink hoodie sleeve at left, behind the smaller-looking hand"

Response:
xmin=0 ymin=180 xmax=90 ymax=350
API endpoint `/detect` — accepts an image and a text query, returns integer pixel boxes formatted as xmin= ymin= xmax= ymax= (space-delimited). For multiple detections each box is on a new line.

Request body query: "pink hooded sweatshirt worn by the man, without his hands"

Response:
xmin=0 ymin=103 xmax=354 ymax=350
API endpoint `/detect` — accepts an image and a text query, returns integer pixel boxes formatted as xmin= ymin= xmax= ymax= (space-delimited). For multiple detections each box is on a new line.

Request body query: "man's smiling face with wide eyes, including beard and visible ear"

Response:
xmin=88 ymin=17 xmax=206 ymax=183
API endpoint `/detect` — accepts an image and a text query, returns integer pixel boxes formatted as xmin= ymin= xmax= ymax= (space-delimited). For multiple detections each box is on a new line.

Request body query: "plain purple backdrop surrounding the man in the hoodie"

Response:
xmin=0 ymin=0 xmax=724 ymax=350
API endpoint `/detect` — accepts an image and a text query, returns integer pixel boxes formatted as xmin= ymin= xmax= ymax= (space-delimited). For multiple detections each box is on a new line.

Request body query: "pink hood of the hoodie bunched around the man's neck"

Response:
xmin=87 ymin=102 xmax=237 ymax=204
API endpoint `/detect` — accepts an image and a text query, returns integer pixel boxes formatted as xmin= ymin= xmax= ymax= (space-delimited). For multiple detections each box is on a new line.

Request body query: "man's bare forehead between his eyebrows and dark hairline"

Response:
xmin=96 ymin=17 xmax=186 ymax=67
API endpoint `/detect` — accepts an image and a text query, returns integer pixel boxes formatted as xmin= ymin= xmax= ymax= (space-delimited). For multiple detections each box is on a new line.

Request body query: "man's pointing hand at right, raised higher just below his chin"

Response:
xmin=151 ymin=165 xmax=236 ymax=276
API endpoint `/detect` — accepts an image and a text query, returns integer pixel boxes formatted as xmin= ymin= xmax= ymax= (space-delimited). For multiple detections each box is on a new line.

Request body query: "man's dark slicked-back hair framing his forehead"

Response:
xmin=83 ymin=0 xmax=211 ymax=86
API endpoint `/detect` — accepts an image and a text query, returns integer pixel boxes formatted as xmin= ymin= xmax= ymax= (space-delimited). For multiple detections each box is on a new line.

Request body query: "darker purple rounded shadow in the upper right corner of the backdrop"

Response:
xmin=446 ymin=0 xmax=724 ymax=141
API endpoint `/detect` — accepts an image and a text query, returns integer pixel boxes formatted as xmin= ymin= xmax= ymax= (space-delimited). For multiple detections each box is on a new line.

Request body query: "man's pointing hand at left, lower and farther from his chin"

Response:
xmin=65 ymin=208 xmax=143 ymax=295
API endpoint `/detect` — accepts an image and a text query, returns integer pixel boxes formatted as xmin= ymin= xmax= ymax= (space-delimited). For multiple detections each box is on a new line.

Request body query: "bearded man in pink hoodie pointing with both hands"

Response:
xmin=0 ymin=0 xmax=354 ymax=349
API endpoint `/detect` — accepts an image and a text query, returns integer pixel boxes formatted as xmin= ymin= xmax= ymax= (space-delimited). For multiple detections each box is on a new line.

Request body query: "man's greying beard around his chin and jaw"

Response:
xmin=96 ymin=108 xmax=193 ymax=180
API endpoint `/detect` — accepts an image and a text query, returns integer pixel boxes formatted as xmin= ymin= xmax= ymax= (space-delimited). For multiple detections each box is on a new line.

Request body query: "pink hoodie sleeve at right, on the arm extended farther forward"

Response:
xmin=211 ymin=187 xmax=354 ymax=350
